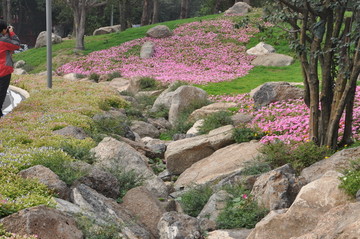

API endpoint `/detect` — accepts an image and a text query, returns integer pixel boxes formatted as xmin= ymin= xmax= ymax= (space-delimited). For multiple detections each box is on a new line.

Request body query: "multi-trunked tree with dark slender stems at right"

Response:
xmin=269 ymin=0 xmax=360 ymax=148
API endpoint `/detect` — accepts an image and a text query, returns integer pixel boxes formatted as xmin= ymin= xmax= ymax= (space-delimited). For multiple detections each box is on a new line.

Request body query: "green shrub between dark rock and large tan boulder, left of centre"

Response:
xmin=106 ymin=167 xmax=146 ymax=202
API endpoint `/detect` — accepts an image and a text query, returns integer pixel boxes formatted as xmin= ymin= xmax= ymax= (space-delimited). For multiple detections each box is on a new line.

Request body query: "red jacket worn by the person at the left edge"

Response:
xmin=0 ymin=32 xmax=20 ymax=77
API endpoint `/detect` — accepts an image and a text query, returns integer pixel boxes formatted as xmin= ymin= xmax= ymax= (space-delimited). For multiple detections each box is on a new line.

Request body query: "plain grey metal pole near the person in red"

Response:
xmin=46 ymin=0 xmax=52 ymax=88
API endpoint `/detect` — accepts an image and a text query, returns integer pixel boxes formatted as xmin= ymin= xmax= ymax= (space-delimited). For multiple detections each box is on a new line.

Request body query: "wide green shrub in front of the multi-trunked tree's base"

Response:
xmin=260 ymin=141 xmax=333 ymax=173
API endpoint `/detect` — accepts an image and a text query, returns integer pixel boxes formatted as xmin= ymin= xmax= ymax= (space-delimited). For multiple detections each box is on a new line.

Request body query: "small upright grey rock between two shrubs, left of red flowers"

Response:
xmin=198 ymin=190 xmax=232 ymax=223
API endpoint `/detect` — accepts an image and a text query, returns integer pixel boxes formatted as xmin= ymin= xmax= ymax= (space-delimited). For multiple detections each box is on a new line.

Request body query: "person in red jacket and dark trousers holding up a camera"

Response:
xmin=0 ymin=20 xmax=20 ymax=117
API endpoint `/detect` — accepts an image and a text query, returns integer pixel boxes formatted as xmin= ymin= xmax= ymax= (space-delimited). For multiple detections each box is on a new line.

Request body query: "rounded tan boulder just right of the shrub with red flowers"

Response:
xmin=251 ymin=164 xmax=306 ymax=210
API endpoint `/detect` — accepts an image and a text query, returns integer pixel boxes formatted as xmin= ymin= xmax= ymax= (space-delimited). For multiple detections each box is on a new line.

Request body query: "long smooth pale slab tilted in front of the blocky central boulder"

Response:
xmin=174 ymin=141 xmax=261 ymax=188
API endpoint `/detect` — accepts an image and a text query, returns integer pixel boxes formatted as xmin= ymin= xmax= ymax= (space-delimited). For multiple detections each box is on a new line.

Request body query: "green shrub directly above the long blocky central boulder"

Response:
xmin=199 ymin=111 xmax=233 ymax=134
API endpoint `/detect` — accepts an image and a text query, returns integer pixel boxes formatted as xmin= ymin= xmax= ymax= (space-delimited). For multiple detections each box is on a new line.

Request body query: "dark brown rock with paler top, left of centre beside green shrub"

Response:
xmin=76 ymin=167 xmax=120 ymax=199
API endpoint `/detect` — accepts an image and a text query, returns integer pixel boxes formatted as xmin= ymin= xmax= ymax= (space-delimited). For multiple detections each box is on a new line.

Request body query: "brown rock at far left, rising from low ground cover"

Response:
xmin=19 ymin=165 xmax=70 ymax=200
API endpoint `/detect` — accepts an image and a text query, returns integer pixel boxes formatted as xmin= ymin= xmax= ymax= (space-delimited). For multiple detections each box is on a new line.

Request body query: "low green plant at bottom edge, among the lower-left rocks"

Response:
xmin=75 ymin=215 xmax=123 ymax=239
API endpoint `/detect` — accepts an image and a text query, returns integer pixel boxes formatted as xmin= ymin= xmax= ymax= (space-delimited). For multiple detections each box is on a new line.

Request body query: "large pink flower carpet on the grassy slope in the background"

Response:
xmin=58 ymin=19 xmax=258 ymax=84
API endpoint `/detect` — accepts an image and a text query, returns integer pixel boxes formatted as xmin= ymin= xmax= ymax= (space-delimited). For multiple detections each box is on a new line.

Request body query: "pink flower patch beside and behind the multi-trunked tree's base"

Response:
xmin=212 ymin=86 xmax=360 ymax=143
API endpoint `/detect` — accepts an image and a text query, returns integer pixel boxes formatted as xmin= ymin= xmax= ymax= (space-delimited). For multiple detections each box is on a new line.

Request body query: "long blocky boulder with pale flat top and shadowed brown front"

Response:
xmin=165 ymin=125 xmax=234 ymax=174
